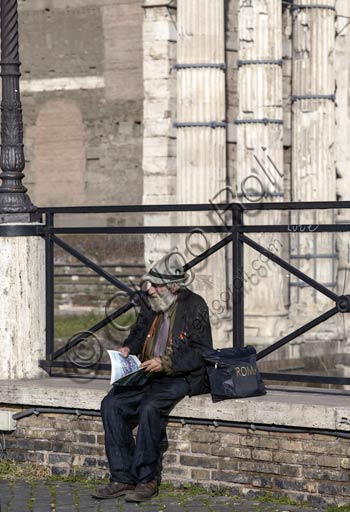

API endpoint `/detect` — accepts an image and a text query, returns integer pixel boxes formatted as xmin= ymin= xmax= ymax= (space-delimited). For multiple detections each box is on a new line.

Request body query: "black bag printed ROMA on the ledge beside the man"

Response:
xmin=203 ymin=346 xmax=266 ymax=402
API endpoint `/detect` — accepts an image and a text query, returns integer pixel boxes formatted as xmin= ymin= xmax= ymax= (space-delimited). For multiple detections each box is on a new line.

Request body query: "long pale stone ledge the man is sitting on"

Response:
xmin=0 ymin=377 xmax=350 ymax=432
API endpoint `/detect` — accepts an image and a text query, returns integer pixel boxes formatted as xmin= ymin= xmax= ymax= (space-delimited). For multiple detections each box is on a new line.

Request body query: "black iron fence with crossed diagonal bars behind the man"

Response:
xmin=35 ymin=201 xmax=350 ymax=385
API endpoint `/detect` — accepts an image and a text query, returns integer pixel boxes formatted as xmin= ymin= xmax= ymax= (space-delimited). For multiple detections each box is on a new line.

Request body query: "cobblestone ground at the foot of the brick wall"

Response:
xmin=0 ymin=480 xmax=340 ymax=512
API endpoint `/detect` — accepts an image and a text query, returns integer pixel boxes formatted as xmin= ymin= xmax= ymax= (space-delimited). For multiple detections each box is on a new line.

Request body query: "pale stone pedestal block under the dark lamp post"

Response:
xmin=0 ymin=230 xmax=45 ymax=379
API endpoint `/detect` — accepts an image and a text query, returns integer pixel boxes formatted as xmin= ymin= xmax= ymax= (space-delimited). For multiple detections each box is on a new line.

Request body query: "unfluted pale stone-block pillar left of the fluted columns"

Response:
xmin=142 ymin=0 xmax=176 ymax=267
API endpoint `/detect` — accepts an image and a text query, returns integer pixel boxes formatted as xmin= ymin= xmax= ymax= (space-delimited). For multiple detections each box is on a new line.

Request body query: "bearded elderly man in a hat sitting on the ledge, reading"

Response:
xmin=92 ymin=254 xmax=212 ymax=502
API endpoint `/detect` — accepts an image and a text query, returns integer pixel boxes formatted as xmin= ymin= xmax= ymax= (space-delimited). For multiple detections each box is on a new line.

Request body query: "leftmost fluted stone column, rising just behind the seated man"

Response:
xmin=176 ymin=0 xmax=227 ymax=346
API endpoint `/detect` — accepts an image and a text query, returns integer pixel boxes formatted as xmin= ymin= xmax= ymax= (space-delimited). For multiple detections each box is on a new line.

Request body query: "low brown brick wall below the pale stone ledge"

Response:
xmin=1 ymin=407 xmax=350 ymax=505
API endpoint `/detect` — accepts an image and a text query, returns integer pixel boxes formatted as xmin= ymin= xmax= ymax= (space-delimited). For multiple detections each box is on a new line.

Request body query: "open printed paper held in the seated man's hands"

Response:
xmin=107 ymin=350 xmax=149 ymax=386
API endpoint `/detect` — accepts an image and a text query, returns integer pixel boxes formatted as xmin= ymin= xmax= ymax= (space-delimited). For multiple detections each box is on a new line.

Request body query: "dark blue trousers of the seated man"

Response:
xmin=101 ymin=376 xmax=189 ymax=483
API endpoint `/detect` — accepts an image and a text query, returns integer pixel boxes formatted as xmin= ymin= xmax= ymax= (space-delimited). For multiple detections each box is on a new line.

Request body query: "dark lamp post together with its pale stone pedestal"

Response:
xmin=0 ymin=0 xmax=45 ymax=380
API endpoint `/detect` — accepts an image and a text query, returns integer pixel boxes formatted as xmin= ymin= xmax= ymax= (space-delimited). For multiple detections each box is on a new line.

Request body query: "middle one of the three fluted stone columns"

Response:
xmin=236 ymin=0 xmax=286 ymax=343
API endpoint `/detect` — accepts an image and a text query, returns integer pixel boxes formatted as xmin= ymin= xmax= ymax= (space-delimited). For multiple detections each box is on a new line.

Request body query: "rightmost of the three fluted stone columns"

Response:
xmin=291 ymin=0 xmax=336 ymax=316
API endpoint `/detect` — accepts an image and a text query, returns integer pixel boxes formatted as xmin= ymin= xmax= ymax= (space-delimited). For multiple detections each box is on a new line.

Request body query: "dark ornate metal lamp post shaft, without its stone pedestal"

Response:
xmin=0 ymin=0 xmax=36 ymax=218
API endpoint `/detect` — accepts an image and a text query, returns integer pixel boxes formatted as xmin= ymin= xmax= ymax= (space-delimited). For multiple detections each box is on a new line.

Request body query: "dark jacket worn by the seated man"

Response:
xmin=123 ymin=288 xmax=213 ymax=396
